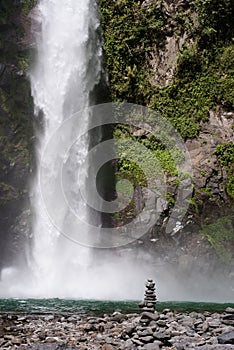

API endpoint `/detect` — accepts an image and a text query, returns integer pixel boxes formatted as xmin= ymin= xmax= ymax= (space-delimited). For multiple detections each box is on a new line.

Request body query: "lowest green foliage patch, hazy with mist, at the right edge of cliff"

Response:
xmin=200 ymin=216 xmax=234 ymax=263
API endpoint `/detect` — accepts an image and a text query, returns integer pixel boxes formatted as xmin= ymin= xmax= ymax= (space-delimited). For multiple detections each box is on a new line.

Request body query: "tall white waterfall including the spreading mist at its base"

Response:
xmin=0 ymin=0 xmax=154 ymax=300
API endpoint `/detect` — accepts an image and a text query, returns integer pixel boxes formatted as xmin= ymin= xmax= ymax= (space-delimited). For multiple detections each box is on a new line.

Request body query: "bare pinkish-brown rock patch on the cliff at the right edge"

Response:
xmin=186 ymin=109 xmax=234 ymax=205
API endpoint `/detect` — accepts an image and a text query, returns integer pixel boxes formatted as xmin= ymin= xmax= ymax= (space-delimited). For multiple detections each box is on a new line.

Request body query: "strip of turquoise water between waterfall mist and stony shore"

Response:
xmin=0 ymin=299 xmax=234 ymax=314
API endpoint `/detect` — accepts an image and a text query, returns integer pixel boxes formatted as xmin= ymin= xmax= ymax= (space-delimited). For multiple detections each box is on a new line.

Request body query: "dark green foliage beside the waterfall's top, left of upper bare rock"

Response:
xmin=100 ymin=0 xmax=166 ymax=105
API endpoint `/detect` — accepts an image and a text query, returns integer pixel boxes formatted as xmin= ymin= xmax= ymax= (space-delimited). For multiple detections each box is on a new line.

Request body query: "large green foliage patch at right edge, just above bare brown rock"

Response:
xmin=150 ymin=45 xmax=234 ymax=139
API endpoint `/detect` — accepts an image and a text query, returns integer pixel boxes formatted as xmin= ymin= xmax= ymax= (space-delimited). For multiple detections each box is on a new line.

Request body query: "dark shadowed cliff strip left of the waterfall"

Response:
xmin=0 ymin=0 xmax=33 ymax=270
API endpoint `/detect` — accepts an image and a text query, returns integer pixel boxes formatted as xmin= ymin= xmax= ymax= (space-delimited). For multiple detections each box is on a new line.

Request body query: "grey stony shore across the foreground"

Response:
xmin=0 ymin=308 xmax=234 ymax=350
